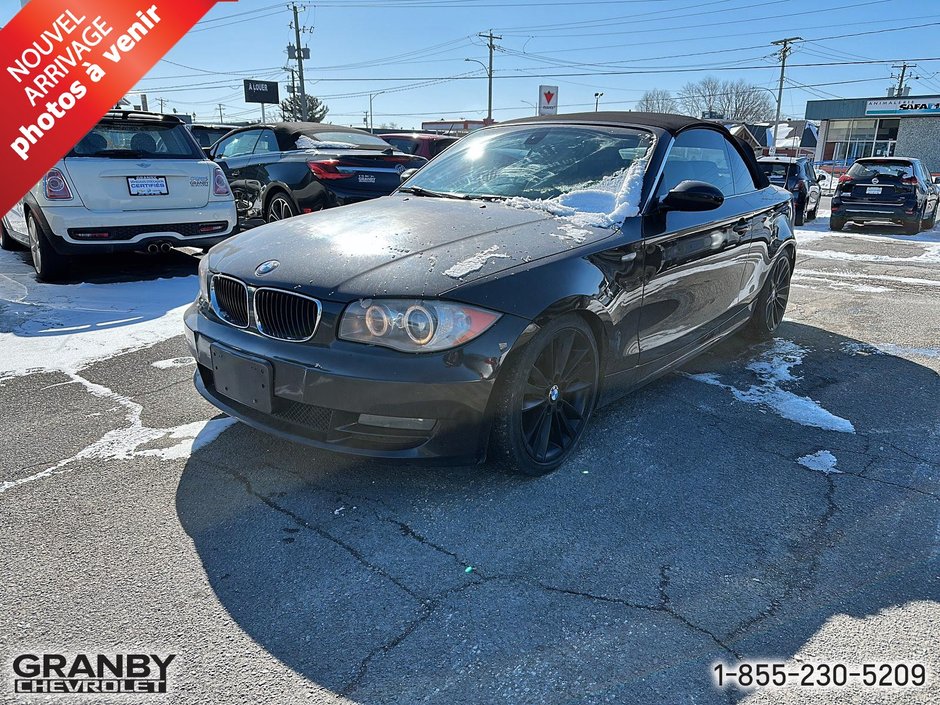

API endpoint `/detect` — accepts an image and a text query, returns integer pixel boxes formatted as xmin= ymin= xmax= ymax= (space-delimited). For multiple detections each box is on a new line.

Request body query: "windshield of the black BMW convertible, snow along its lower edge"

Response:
xmin=403 ymin=125 xmax=654 ymax=206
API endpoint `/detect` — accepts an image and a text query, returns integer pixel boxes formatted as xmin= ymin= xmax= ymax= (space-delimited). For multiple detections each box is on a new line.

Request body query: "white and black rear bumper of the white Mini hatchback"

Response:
xmin=39 ymin=201 xmax=237 ymax=254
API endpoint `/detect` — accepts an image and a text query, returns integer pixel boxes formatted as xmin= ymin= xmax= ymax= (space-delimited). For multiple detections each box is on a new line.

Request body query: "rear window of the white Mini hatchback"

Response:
xmin=68 ymin=120 xmax=205 ymax=159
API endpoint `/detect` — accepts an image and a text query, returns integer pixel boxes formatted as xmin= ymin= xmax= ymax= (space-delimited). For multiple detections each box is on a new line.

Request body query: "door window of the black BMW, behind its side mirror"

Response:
xmin=656 ymin=129 xmax=740 ymax=198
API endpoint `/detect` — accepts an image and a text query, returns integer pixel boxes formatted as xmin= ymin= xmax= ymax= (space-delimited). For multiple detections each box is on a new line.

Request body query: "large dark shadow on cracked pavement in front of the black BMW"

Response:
xmin=177 ymin=322 xmax=940 ymax=704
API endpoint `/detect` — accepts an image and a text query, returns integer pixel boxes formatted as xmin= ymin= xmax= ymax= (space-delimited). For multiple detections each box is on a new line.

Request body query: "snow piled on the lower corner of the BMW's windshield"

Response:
xmin=505 ymin=159 xmax=647 ymax=228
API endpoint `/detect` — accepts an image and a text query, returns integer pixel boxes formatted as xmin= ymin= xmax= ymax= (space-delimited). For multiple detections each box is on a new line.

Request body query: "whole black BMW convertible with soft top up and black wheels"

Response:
xmin=185 ymin=113 xmax=796 ymax=475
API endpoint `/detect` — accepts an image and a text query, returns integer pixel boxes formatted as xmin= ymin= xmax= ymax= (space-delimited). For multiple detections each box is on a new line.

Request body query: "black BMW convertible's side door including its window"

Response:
xmin=639 ymin=128 xmax=755 ymax=372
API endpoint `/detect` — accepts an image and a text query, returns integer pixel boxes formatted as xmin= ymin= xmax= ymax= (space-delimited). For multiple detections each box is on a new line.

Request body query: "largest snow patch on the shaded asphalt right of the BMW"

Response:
xmin=687 ymin=339 xmax=855 ymax=433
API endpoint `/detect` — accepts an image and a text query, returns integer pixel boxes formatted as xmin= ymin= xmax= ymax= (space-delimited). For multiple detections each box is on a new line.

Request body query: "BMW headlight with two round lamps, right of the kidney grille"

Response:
xmin=339 ymin=299 xmax=500 ymax=352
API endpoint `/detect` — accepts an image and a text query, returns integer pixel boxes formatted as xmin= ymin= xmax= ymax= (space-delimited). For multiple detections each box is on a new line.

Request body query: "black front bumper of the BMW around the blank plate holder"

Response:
xmin=184 ymin=302 xmax=529 ymax=462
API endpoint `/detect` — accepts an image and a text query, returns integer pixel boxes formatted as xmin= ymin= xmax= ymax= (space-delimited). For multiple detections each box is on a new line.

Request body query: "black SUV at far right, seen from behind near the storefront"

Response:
xmin=829 ymin=157 xmax=940 ymax=235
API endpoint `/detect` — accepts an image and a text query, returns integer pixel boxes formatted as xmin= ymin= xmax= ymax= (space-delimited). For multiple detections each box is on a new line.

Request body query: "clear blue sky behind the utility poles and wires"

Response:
xmin=0 ymin=0 xmax=940 ymax=128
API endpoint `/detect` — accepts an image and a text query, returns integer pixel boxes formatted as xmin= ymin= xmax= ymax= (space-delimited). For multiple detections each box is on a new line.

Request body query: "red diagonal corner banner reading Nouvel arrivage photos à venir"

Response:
xmin=0 ymin=0 xmax=234 ymax=214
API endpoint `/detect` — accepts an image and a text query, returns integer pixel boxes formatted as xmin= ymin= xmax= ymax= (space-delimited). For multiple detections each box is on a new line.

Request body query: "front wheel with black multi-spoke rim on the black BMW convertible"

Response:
xmin=490 ymin=314 xmax=600 ymax=477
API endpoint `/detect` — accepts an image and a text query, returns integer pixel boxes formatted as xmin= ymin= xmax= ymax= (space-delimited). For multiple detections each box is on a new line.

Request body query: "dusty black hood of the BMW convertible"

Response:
xmin=209 ymin=194 xmax=616 ymax=302
